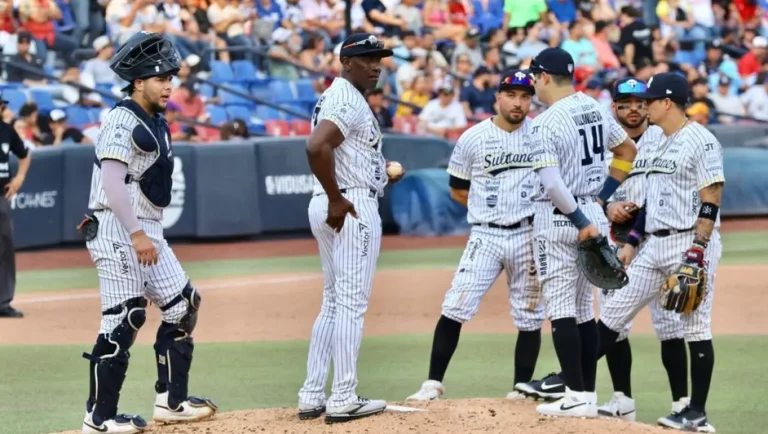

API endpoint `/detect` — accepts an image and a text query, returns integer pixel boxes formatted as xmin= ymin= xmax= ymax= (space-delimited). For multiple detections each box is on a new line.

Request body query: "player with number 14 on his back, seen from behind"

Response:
xmin=530 ymin=48 xmax=637 ymax=417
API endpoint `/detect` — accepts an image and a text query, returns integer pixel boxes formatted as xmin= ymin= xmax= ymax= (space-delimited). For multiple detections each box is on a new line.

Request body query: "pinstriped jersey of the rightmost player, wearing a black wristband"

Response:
xmin=645 ymin=122 xmax=725 ymax=232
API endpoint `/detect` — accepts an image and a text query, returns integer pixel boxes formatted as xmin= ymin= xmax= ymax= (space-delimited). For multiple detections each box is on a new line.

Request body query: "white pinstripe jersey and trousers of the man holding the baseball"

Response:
xmin=299 ymin=78 xmax=387 ymax=407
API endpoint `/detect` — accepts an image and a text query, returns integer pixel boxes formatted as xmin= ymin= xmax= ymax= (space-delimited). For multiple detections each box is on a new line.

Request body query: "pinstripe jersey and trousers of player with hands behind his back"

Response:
xmin=442 ymin=118 xmax=544 ymax=331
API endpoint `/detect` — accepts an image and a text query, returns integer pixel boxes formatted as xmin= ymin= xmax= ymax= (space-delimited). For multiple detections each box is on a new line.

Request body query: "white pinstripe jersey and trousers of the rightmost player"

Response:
xmin=600 ymin=122 xmax=725 ymax=342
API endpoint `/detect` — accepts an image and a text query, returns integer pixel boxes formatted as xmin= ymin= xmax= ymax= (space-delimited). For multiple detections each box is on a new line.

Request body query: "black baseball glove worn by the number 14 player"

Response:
xmin=576 ymin=235 xmax=629 ymax=289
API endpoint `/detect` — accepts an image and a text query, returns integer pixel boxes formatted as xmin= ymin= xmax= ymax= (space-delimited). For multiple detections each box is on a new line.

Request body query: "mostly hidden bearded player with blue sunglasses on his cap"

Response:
xmin=516 ymin=77 xmax=688 ymax=421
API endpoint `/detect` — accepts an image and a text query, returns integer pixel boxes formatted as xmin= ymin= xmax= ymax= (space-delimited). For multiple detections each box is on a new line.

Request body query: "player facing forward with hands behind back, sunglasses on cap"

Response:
xmin=407 ymin=70 xmax=544 ymax=401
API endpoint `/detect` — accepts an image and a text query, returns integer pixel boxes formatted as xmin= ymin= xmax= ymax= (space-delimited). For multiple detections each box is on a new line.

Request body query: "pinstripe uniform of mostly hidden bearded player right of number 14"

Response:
xmin=598 ymin=125 xmax=683 ymax=342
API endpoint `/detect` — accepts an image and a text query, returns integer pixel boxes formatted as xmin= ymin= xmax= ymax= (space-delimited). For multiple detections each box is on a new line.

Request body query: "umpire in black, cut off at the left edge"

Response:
xmin=0 ymin=92 xmax=31 ymax=318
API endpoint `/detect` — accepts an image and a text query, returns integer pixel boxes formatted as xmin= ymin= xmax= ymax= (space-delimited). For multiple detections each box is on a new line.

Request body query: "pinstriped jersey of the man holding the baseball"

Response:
xmin=312 ymin=77 xmax=387 ymax=196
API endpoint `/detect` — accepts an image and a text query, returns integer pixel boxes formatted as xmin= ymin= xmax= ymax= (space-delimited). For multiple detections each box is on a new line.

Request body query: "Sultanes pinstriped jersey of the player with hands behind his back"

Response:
xmin=448 ymin=118 xmax=537 ymax=225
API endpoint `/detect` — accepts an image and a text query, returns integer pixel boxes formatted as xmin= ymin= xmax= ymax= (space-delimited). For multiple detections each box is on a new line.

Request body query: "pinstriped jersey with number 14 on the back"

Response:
xmin=531 ymin=92 xmax=627 ymax=200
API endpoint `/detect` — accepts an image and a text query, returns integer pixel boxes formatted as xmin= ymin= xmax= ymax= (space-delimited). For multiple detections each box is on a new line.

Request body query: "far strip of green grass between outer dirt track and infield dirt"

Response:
xmin=17 ymin=231 xmax=768 ymax=293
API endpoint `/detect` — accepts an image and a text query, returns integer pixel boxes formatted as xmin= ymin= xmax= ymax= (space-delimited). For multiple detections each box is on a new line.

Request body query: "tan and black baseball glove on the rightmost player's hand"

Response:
xmin=660 ymin=254 xmax=707 ymax=314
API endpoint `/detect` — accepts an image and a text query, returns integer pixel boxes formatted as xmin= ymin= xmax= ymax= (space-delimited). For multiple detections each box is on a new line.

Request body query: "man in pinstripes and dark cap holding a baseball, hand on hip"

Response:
xmin=299 ymin=33 xmax=402 ymax=423
